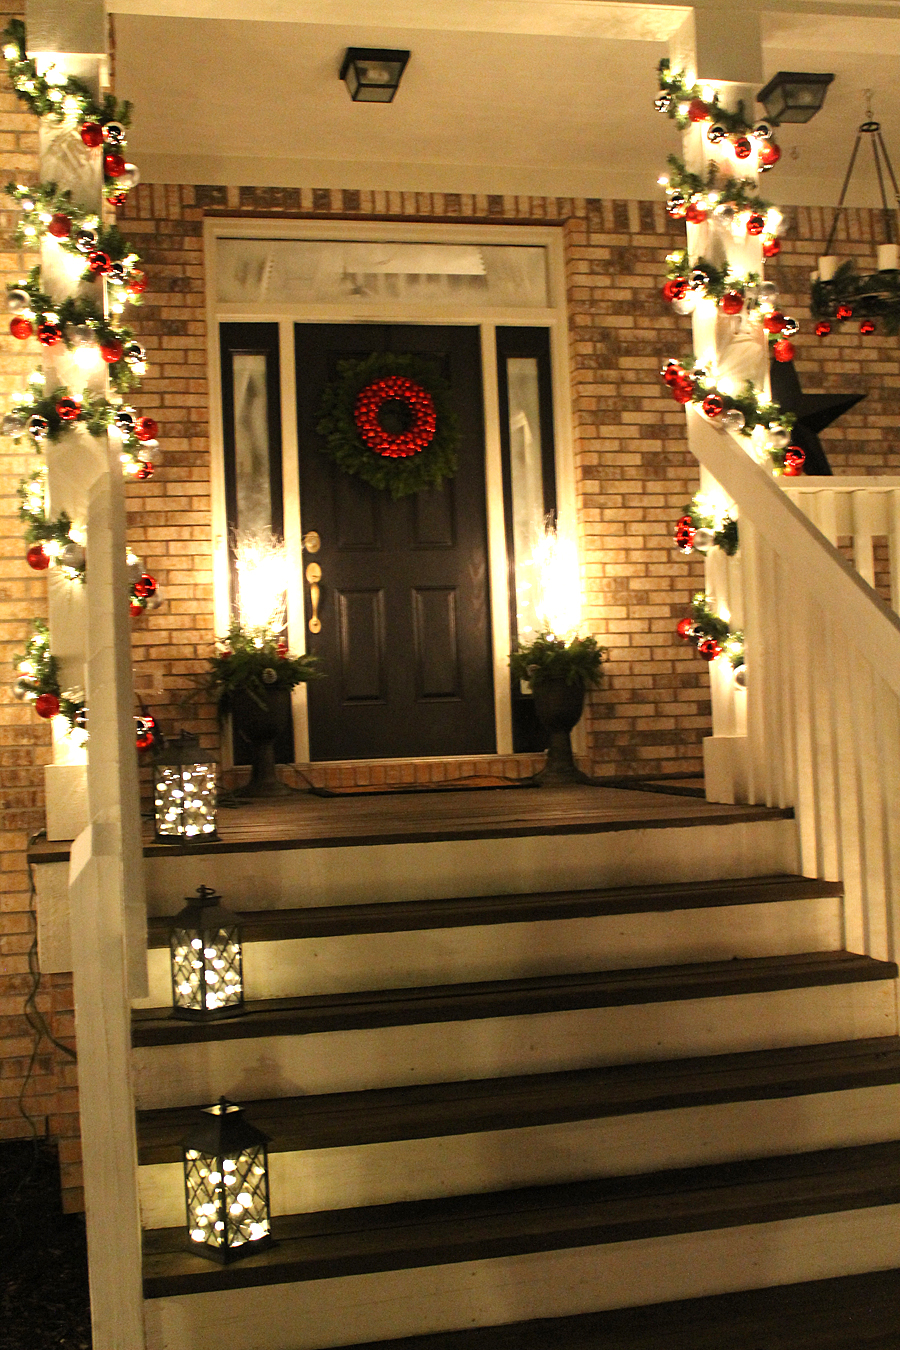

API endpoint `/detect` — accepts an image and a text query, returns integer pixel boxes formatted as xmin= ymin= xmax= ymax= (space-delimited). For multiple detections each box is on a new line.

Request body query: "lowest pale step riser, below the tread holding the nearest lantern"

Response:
xmin=144 ymin=1206 xmax=900 ymax=1350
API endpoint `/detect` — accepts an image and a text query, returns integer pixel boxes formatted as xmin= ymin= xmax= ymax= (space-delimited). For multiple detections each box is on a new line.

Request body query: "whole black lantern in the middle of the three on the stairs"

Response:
xmin=169 ymin=886 xmax=244 ymax=1021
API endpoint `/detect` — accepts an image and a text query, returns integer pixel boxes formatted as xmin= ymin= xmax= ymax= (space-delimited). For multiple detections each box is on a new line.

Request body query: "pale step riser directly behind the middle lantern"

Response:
xmin=135 ymin=896 xmax=842 ymax=1007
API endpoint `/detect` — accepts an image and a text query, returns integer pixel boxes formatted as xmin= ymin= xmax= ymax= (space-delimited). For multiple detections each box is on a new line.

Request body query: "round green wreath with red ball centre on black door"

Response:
xmin=316 ymin=352 xmax=460 ymax=501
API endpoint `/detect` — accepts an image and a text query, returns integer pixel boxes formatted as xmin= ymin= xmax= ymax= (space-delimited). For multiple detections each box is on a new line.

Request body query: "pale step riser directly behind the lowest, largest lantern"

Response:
xmin=140 ymin=1085 xmax=900 ymax=1229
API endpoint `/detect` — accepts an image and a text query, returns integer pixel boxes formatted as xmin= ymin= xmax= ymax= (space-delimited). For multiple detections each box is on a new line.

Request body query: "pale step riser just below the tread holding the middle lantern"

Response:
xmin=134 ymin=980 xmax=896 ymax=1110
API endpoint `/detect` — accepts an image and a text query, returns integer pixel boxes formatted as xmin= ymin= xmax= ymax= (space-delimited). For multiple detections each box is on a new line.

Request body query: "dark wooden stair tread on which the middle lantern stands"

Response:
xmin=132 ymin=952 xmax=897 ymax=1046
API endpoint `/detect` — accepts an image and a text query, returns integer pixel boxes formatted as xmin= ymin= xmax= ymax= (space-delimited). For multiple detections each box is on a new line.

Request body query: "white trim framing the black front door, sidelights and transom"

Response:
xmin=204 ymin=217 xmax=583 ymax=763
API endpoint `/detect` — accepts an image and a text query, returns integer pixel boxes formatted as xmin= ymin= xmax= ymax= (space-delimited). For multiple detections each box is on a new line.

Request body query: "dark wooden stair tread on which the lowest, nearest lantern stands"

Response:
xmin=144 ymin=1142 xmax=900 ymax=1297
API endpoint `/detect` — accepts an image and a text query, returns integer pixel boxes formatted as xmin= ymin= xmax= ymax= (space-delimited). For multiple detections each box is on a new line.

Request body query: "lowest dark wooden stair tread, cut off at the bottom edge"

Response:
xmin=330 ymin=1270 xmax=900 ymax=1350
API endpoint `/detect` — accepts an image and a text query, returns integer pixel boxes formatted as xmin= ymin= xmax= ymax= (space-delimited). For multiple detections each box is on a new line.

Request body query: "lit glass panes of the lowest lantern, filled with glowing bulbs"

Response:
xmin=185 ymin=1143 xmax=270 ymax=1260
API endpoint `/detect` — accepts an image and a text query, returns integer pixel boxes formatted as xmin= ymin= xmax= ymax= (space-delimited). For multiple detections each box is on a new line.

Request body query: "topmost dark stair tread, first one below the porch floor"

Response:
xmin=148 ymin=875 xmax=843 ymax=948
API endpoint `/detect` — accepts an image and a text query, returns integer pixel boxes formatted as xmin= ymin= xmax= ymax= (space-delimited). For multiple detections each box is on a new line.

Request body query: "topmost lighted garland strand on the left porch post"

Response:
xmin=3 ymin=19 xmax=139 ymax=207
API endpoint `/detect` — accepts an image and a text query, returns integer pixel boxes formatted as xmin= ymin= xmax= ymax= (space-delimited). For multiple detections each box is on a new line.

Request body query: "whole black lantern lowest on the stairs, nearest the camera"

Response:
xmin=182 ymin=1098 xmax=271 ymax=1265
